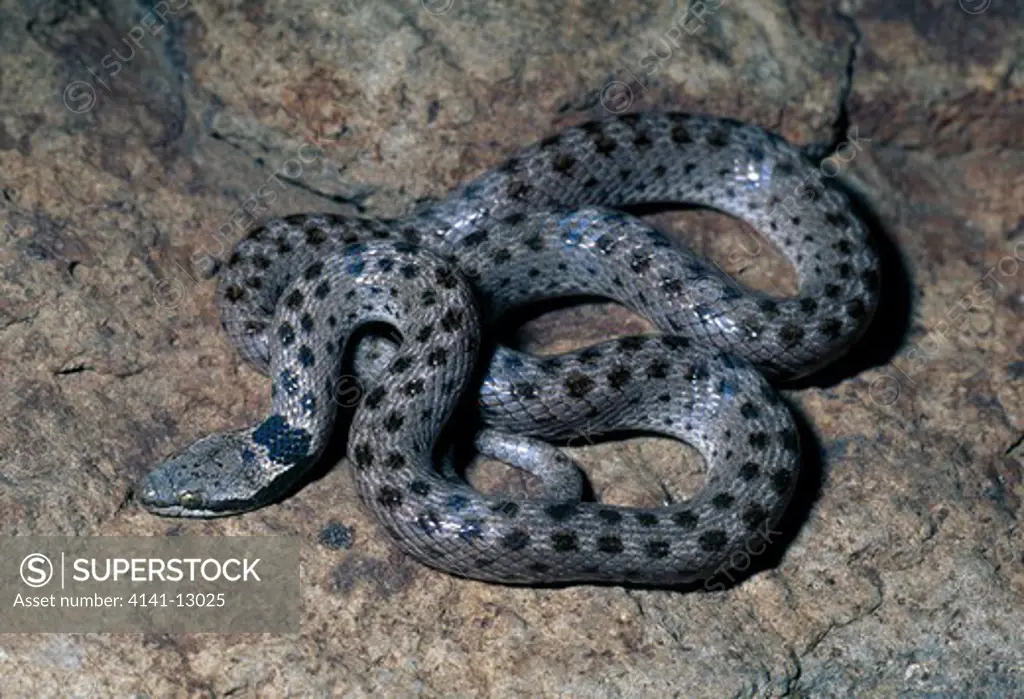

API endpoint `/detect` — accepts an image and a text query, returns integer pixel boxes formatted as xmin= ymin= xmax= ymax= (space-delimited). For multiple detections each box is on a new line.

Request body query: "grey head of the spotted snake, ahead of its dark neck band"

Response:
xmin=139 ymin=430 xmax=274 ymax=517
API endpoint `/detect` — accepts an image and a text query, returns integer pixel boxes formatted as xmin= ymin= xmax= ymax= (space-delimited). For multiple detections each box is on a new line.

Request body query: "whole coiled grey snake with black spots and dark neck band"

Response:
xmin=139 ymin=112 xmax=881 ymax=585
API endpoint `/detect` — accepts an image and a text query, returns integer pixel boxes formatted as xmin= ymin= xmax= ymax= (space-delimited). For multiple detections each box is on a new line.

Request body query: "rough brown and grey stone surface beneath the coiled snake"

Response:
xmin=0 ymin=0 xmax=1024 ymax=697
